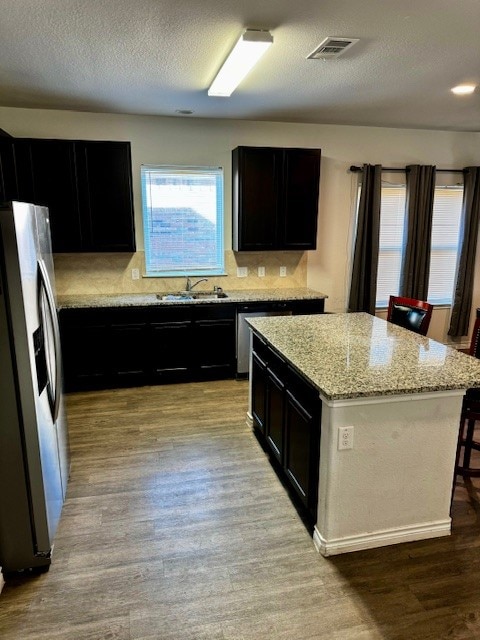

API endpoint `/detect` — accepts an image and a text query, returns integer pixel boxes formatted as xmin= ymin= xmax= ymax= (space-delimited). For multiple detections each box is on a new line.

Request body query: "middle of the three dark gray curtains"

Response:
xmin=400 ymin=165 xmax=436 ymax=300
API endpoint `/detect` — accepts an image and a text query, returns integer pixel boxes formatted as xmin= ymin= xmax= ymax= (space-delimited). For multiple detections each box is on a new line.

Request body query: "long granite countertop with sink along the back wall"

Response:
xmin=57 ymin=287 xmax=327 ymax=309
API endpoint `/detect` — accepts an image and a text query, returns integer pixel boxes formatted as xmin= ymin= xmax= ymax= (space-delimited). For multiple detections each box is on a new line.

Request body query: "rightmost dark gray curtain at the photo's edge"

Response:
xmin=448 ymin=167 xmax=480 ymax=336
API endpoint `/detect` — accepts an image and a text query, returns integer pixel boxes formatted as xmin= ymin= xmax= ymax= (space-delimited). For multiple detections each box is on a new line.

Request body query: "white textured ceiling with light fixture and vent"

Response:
xmin=0 ymin=0 xmax=480 ymax=131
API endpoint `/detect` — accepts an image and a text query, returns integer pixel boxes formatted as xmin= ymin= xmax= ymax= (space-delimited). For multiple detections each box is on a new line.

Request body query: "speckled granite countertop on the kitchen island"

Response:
xmin=247 ymin=313 xmax=480 ymax=400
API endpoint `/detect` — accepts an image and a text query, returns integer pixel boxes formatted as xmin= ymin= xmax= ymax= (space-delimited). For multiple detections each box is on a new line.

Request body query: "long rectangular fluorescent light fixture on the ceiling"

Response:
xmin=208 ymin=29 xmax=273 ymax=97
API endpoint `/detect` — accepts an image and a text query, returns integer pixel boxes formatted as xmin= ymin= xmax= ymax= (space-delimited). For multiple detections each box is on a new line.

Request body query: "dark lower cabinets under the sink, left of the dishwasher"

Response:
xmin=60 ymin=305 xmax=236 ymax=391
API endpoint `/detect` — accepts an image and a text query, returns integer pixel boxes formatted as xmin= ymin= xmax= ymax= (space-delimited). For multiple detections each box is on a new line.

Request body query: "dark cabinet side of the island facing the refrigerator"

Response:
xmin=251 ymin=335 xmax=321 ymax=526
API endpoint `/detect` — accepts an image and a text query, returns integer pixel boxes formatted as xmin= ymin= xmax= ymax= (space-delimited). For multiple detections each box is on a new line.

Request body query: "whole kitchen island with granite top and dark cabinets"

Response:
xmin=249 ymin=313 xmax=480 ymax=556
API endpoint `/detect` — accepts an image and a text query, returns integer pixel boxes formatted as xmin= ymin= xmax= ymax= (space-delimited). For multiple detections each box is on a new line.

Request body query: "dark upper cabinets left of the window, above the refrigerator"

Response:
xmin=0 ymin=138 xmax=135 ymax=253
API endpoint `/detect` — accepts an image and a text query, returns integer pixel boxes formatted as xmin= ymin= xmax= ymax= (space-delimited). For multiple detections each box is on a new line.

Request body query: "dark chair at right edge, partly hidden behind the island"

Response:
xmin=455 ymin=318 xmax=480 ymax=478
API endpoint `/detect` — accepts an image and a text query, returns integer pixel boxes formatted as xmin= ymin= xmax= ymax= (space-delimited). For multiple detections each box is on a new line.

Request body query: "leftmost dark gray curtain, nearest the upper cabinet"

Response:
xmin=348 ymin=164 xmax=382 ymax=315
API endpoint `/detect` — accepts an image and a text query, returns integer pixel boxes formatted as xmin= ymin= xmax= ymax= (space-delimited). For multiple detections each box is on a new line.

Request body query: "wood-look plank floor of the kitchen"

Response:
xmin=0 ymin=381 xmax=480 ymax=640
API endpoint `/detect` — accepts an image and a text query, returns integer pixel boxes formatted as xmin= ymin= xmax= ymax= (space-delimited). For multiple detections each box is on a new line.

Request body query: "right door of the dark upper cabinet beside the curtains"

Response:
xmin=279 ymin=149 xmax=320 ymax=251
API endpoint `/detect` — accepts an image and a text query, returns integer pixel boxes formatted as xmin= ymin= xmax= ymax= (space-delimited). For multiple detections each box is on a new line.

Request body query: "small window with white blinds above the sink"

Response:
xmin=141 ymin=165 xmax=225 ymax=277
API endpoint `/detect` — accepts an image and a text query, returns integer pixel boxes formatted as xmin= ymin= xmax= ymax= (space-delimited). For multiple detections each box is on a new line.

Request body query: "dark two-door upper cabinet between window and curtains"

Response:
xmin=232 ymin=147 xmax=321 ymax=251
